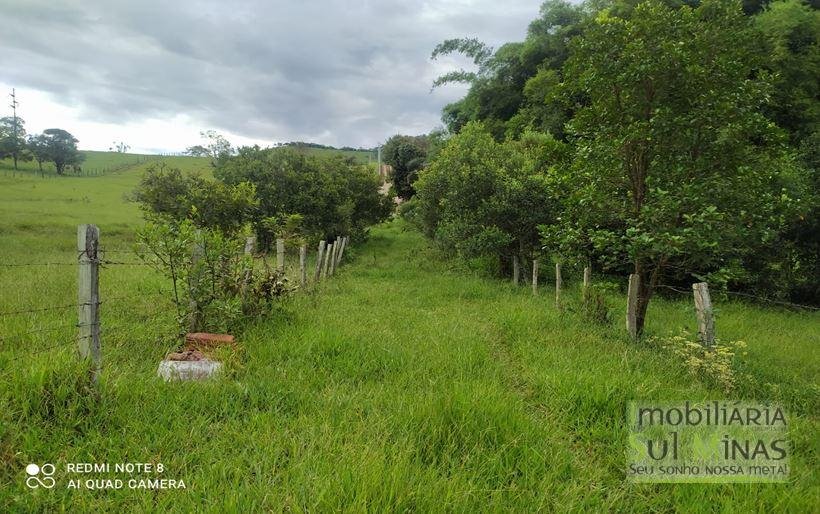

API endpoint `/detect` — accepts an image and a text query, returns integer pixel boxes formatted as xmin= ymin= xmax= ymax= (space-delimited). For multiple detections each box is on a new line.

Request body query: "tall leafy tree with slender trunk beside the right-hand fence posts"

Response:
xmin=552 ymin=0 xmax=800 ymax=331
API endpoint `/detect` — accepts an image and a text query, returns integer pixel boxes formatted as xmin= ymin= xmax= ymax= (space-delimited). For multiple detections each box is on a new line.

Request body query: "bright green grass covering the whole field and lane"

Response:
xmin=0 ymin=154 xmax=820 ymax=512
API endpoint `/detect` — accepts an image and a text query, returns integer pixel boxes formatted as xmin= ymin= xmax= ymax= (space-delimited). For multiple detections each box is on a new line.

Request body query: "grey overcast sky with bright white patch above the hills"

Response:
xmin=0 ymin=0 xmax=541 ymax=152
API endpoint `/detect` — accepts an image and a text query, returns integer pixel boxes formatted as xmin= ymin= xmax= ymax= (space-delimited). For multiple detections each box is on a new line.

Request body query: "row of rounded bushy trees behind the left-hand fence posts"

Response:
xmin=132 ymin=146 xmax=393 ymax=247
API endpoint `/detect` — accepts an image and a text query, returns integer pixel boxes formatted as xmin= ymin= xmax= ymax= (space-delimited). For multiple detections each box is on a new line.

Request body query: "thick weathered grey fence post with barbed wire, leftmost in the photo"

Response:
xmin=77 ymin=225 xmax=102 ymax=382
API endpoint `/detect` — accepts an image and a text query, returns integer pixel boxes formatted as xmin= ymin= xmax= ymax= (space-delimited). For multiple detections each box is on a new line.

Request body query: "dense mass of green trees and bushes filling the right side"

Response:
xmin=394 ymin=0 xmax=820 ymax=336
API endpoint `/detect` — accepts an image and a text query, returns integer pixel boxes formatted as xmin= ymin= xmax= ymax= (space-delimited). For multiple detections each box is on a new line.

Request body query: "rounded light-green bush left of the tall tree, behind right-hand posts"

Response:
xmin=412 ymin=123 xmax=563 ymax=274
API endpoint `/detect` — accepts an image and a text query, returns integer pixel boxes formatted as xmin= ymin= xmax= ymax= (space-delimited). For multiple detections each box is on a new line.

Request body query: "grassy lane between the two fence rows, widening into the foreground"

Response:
xmin=0 ymin=218 xmax=818 ymax=512
